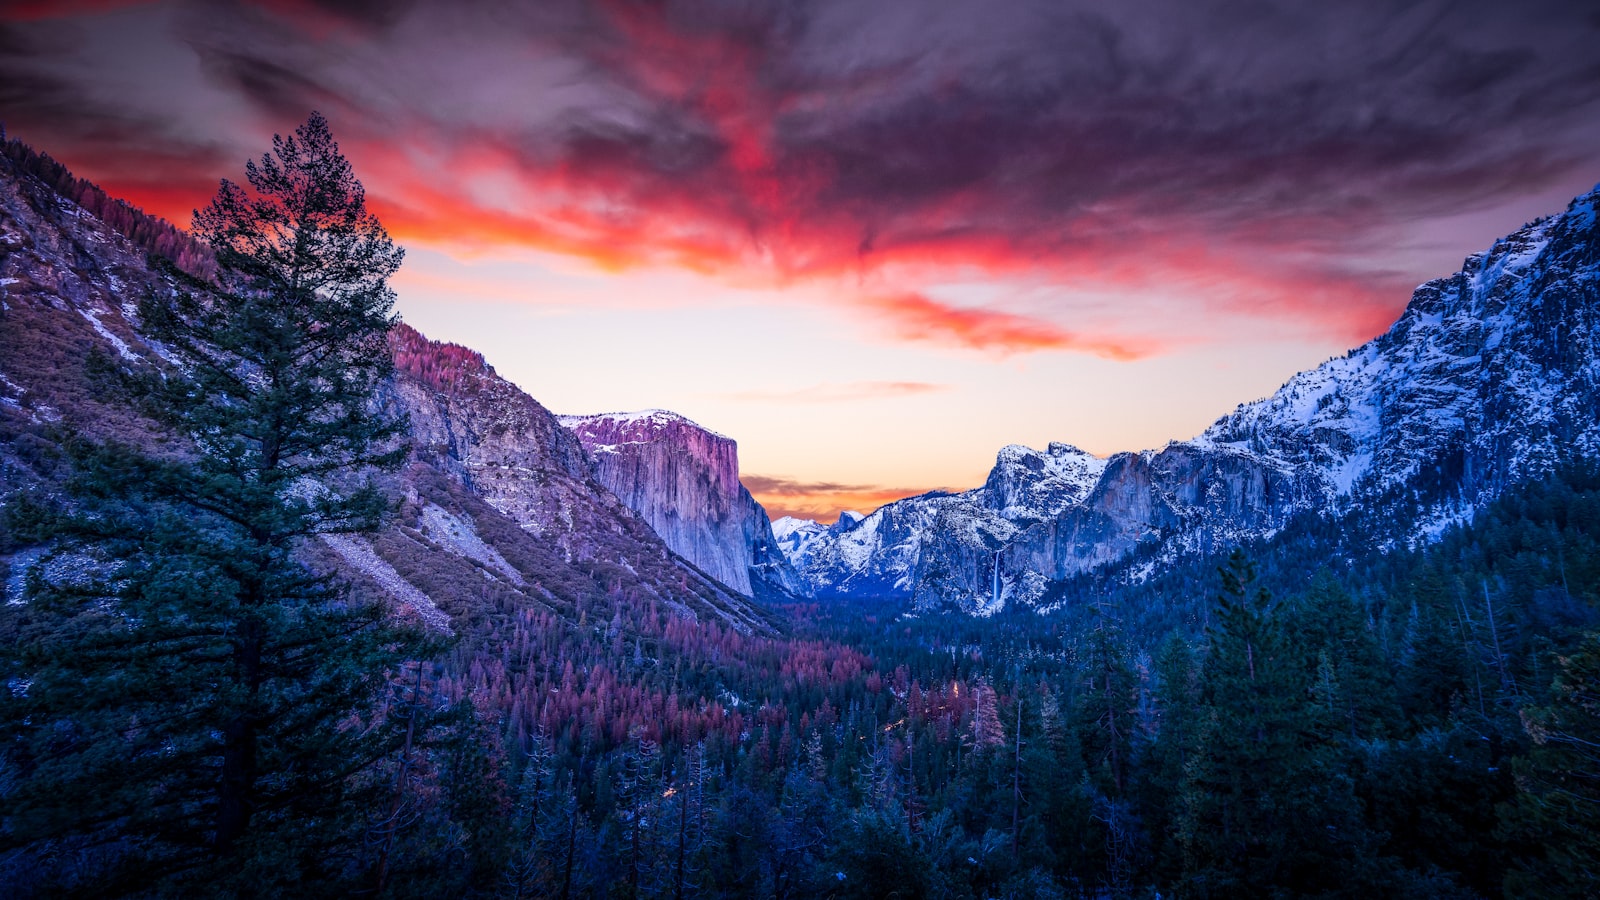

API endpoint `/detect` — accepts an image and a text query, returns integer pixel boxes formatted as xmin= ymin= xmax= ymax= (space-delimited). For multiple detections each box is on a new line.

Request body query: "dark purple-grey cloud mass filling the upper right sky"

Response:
xmin=761 ymin=3 xmax=1600 ymax=239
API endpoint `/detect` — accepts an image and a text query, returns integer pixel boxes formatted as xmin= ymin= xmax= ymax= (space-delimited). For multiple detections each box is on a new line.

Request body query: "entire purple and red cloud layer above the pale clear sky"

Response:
xmin=0 ymin=0 xmax=1600 ymax=360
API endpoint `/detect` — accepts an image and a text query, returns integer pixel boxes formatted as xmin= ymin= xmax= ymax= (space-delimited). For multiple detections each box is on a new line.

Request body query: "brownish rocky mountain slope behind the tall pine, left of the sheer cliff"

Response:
xmin=0 ymin=143 xmax=773 ymax=634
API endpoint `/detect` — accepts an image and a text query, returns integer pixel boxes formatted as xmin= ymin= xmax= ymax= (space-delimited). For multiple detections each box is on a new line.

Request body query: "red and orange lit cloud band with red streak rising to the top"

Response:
xmin=11 ymin=0 xmax=1459 ymax=360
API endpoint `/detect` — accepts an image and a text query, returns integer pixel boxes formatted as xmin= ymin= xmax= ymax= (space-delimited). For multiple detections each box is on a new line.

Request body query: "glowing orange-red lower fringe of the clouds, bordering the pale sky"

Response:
xmin=72 ymin=123 xmax=1408 ymax=360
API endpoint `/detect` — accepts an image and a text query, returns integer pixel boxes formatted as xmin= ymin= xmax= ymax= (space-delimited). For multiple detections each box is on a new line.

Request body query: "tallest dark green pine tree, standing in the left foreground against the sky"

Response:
xmin=3 ymin=114 xmax=422 ymax=892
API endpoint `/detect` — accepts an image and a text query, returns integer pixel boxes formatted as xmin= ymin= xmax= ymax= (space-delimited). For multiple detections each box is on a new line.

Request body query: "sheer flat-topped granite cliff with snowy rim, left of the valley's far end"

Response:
xmin=560 ymin=410 xmax=802 ymax=596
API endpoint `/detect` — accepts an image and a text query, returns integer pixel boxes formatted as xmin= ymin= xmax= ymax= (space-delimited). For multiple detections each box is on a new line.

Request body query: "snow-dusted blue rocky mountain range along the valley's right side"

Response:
xmin=778 ymin=189 xmax=1600 ymax=615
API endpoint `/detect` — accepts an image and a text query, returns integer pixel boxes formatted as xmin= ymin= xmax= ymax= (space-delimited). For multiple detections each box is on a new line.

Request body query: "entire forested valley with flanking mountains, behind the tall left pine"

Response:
xmin=0 ymin=120 xmax=1600 ymax=898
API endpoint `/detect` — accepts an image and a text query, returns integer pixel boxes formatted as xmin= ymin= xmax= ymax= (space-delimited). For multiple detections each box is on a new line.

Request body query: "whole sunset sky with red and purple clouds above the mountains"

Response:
xmin=0 ymin=0 xmax=1600 ymax=520
